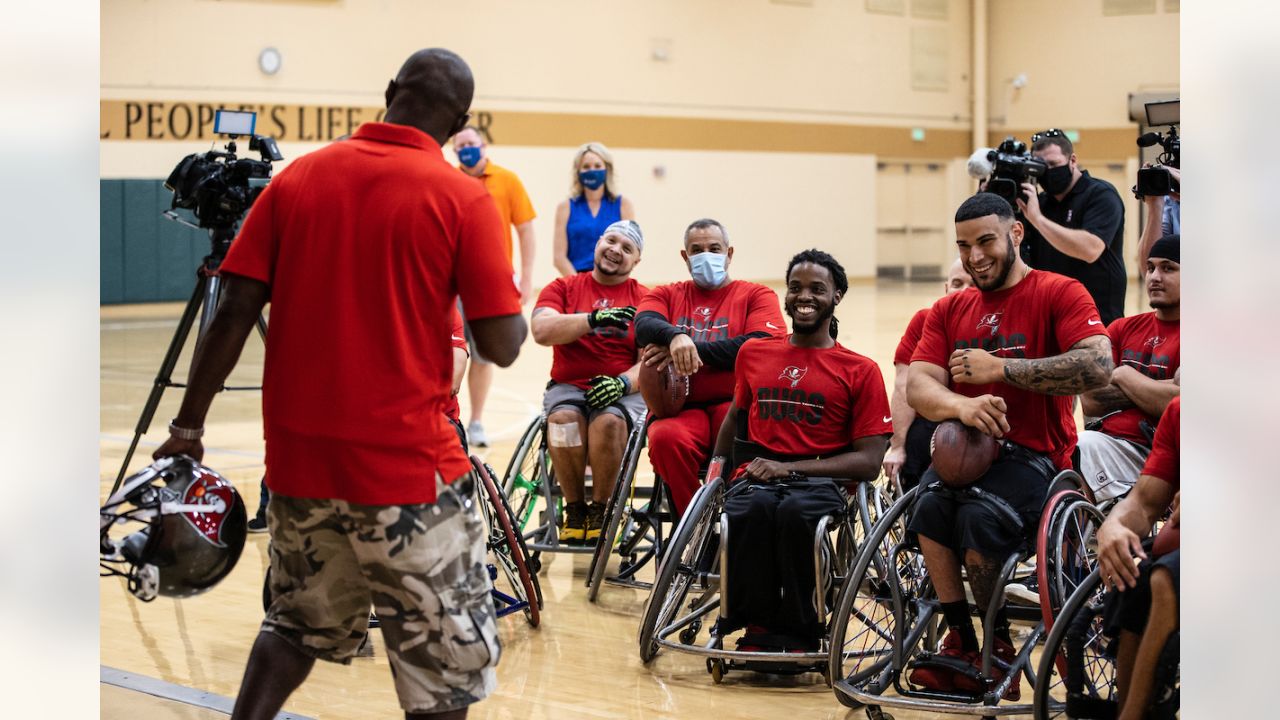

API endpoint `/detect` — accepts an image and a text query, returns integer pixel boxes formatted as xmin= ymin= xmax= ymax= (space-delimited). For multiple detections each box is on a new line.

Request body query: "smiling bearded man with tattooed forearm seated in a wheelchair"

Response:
xmin=906 ymin=192 xmax=1111 ymax=700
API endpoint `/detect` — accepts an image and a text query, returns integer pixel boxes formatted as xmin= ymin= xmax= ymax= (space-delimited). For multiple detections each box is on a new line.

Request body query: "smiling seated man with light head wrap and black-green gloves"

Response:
xmin=530 ymin=220 xmax=648 ymax=544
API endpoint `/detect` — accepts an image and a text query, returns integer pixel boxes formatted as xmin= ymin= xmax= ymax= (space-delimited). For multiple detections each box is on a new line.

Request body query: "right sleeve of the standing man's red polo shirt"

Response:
xmin=458 ymin=192 xmax=520 ymax=320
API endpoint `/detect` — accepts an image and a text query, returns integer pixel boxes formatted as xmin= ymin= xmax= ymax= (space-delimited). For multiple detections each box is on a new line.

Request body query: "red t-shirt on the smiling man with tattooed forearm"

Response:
xmin=911 ymin=270 xmax=1106 ymax=469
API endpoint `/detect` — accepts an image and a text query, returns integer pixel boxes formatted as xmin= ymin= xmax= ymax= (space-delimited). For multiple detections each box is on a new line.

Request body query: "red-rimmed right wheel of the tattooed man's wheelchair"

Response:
xmin=1036 ymin=489 xmax=1103 ymax=632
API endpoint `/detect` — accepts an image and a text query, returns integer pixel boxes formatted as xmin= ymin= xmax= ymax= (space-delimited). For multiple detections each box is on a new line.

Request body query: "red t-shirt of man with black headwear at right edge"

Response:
xmin=1102 ymin=313 xmax=1179 ymax=445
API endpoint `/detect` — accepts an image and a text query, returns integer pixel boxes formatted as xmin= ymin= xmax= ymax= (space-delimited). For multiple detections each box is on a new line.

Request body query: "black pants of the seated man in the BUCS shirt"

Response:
xmin=721 ymin=478 xmax=846 ymax=642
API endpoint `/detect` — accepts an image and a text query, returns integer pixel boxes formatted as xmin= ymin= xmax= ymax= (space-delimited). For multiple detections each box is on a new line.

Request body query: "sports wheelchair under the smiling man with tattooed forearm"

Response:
xmin=827 ymin=470 xmax=1102 ymax=720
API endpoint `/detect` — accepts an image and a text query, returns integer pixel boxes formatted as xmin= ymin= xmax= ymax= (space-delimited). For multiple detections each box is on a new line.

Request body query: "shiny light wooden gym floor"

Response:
xmin=100 ymin=282 xmax=1146 ymax=720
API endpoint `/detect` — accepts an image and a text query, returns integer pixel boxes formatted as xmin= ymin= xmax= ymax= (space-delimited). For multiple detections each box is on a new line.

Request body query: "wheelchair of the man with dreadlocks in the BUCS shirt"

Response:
xmin=639 ymin=456 xmax=884 ymax=683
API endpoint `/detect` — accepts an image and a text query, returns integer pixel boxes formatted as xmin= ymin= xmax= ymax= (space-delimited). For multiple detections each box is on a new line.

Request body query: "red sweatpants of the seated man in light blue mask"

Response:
xmin=649 ymin=402 xmax=730 ymax=514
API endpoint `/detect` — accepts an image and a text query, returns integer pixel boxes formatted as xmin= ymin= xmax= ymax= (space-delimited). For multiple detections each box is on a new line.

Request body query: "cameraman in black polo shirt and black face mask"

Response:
xmin=1018 ymin=129 xmax=1128 ymax=324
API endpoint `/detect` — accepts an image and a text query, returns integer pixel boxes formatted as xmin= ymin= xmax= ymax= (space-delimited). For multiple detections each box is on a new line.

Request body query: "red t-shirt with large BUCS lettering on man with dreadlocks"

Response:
xmin=733 ymin=336 xmax=893 ymax=456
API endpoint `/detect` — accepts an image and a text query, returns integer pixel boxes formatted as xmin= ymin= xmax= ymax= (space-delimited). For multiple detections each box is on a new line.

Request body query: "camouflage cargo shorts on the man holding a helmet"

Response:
xmin=262 ymin=475 xmax=500 ymax=712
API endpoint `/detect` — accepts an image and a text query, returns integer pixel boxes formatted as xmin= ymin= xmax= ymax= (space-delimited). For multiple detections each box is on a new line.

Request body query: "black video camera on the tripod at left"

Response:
xmin=164 ymin=110 xmax=284 ymax=231
